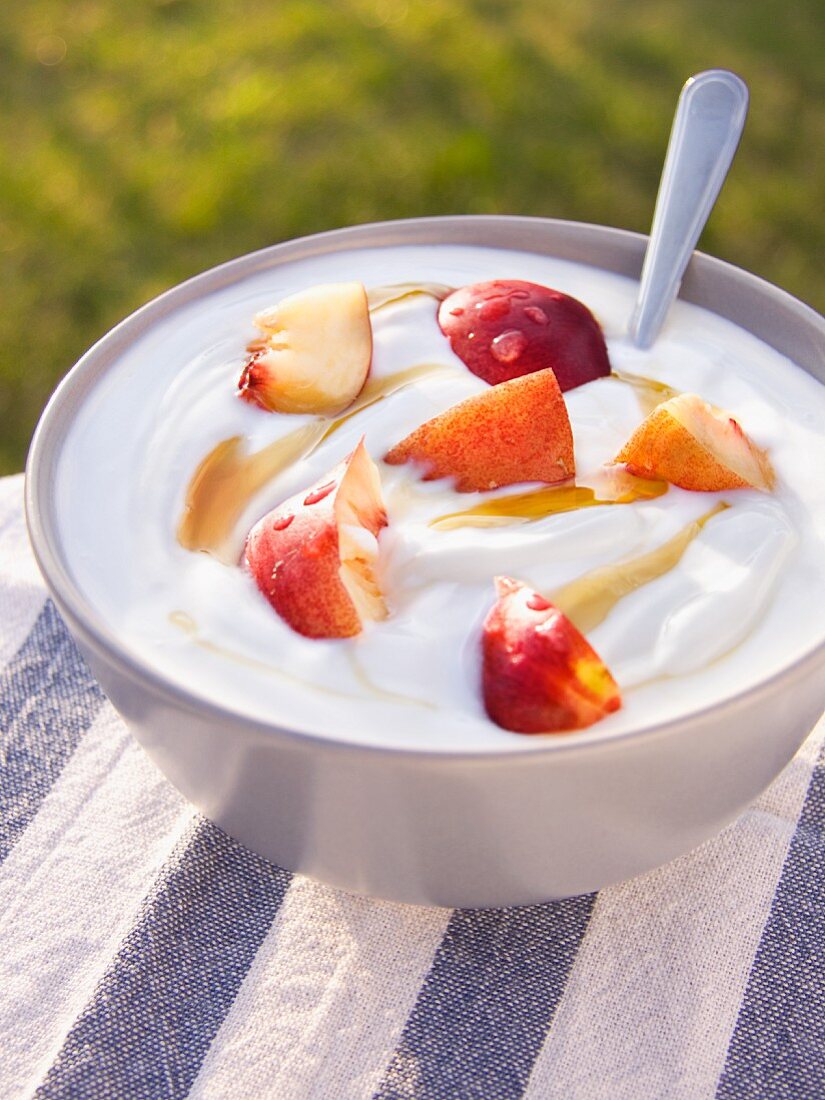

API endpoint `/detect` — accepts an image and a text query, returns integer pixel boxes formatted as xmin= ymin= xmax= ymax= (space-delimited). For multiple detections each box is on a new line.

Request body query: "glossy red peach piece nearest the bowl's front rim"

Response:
xmin=482 ymin=576 xmax=622 ymax=734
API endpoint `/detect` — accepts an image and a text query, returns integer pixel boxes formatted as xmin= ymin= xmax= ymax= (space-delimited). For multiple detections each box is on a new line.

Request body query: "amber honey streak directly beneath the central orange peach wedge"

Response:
xmin=429 ymin=468 xmax=668 ymax=531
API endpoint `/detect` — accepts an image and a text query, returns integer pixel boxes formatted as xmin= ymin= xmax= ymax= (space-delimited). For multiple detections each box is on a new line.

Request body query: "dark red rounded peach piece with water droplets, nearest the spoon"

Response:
xmin=438 ymin=279 xmax=611 ymax=391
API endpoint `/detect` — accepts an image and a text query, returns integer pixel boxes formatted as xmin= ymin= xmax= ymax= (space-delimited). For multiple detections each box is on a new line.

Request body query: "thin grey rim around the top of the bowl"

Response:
xmin=24 ymin=215 xmax=825 ymax=765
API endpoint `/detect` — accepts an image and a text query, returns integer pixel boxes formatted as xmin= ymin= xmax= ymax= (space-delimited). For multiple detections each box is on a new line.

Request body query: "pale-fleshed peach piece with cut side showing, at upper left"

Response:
xmin=238 ymin=283 xmax=373 ymax=416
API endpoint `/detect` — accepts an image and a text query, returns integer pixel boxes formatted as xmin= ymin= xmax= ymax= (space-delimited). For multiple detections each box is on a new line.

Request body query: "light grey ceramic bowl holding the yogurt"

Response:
xmin=26 ymin=217 xmax=825 ymax=906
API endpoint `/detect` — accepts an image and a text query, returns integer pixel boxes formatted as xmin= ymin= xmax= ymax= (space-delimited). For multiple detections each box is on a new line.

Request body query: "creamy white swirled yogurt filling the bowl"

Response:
xmin=56 ymin=245 xmax=825 ymax=750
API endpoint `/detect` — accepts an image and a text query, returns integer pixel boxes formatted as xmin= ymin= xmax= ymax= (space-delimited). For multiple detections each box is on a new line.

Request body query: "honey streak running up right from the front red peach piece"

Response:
xmin=547 ymin=502 xmax=730 ymax=634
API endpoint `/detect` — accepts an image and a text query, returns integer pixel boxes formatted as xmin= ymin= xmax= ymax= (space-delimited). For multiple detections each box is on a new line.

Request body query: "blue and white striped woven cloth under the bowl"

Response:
xmin=0 ymin=477 xmax=825 ymax=1100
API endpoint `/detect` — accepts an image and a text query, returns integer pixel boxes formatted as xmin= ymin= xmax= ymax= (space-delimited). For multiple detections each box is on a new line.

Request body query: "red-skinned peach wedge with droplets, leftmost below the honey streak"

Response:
xmin=245 ymin=439 xmax=387 ymax=638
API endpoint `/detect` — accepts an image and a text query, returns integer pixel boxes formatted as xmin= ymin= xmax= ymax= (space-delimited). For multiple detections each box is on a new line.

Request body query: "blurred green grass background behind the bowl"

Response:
xmin=0 ymin=0 xmax=825 ymax=473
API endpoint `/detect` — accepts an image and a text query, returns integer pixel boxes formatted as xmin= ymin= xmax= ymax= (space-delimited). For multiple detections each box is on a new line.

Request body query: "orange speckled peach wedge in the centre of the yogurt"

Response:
xmin=384 ymin=370 xmax=575 ymax=493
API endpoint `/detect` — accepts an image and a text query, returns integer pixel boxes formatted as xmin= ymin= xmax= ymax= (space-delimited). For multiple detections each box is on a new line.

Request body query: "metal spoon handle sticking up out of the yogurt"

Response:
xmin=629 ymin=69 xmax=748 ymax=348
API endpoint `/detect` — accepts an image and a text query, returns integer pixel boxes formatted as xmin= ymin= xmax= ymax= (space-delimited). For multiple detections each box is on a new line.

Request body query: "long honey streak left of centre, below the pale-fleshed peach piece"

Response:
xmin=177 ymin=363 xmax=451 ymax=564
